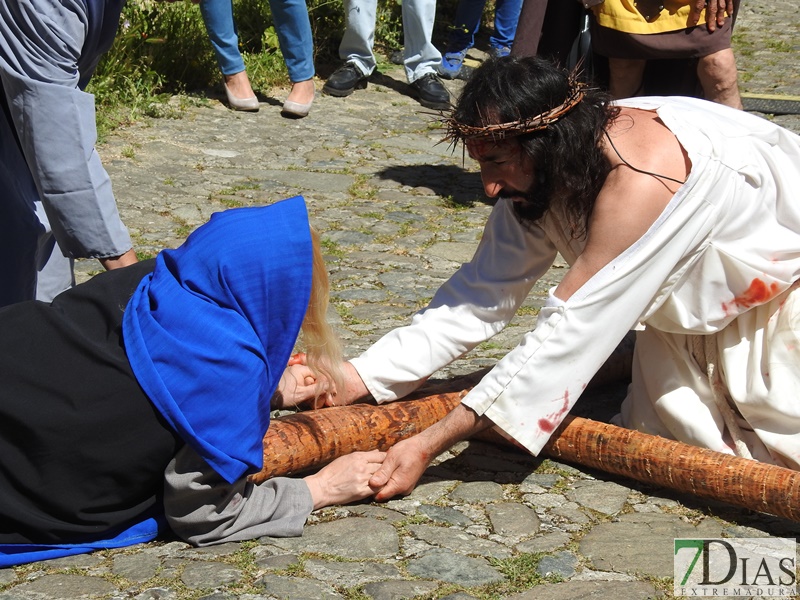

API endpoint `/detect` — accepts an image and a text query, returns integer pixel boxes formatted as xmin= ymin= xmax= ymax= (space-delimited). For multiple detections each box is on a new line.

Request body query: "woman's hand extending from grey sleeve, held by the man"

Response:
xmin=303 ymin=450 xmax=386 ymax=510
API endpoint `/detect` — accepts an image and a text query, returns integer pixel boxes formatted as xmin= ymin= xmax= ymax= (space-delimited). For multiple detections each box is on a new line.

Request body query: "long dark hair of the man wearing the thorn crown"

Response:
xmin=452 ymin=57 xmax=619 ymax=238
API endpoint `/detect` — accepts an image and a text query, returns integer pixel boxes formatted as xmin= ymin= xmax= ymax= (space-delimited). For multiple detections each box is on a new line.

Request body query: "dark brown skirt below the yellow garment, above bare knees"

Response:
xmin=591 ymin=0 xmax=739 ymax=60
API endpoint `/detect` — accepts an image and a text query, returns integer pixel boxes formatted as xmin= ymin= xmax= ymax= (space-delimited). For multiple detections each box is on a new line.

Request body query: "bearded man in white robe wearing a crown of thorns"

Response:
xmin=290 ymin=57 xmax=800 ymax=500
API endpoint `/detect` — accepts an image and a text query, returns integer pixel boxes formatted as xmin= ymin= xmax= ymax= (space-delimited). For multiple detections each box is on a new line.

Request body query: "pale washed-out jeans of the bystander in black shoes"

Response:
xmin=339 ymin=0 xmax=442 ymax=83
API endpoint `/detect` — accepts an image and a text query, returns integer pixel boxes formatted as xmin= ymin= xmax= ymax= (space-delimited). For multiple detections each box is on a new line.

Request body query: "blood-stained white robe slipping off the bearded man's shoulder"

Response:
xmin=352 ymin=98 xmax=800 ymax=468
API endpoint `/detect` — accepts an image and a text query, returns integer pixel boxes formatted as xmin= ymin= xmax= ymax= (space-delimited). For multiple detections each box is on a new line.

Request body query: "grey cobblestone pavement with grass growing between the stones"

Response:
xmin=0 ymin=0 xmax=800 ymax=600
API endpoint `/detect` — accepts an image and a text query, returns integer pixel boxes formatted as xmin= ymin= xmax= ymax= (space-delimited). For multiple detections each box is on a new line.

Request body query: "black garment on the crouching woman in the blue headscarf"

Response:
xmin=0 ymin=261 xmax=180 ymax=543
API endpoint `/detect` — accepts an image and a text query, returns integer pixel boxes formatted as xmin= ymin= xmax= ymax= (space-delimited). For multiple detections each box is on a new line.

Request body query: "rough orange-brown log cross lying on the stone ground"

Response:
xmin=251 ymin=374 xmax=800 ymax=521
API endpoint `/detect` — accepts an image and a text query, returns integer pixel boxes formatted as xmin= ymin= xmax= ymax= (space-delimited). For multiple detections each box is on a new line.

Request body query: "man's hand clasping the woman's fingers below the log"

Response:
xmin=369 ymin=435 xmax=434 ymax=501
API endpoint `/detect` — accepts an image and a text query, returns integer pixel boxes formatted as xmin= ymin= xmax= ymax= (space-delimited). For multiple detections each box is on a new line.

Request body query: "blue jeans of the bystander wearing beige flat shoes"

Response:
xmin=200 ymin=0 xmax=314 ymax=82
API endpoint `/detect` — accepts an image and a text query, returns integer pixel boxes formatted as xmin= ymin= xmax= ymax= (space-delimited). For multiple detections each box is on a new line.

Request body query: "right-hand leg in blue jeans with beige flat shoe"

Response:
xmin=269 ymin=0 xmax=314 ymax=117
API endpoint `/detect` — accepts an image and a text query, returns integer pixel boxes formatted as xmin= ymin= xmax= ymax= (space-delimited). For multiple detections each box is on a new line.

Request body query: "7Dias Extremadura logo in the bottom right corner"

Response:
xmin=674 ymin=538 xmax=797 ymax=598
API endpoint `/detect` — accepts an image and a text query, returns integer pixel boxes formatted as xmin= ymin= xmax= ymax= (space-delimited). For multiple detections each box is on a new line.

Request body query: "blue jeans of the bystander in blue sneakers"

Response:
xmin=447 ymin=0 xmax=520 ymax=51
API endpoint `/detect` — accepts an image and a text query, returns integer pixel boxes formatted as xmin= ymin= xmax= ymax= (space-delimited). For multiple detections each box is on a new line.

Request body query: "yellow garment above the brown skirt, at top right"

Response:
xmin=592 ymin=0 xmax=706 ymax=34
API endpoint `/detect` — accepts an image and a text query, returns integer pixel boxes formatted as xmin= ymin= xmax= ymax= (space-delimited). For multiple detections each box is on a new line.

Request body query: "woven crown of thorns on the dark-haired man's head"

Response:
xmin=441 ymin=74 xmax=587 ymax=144
